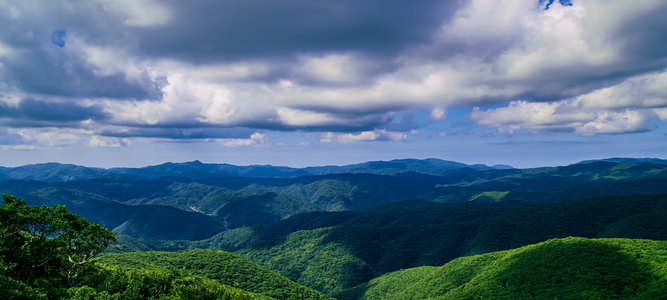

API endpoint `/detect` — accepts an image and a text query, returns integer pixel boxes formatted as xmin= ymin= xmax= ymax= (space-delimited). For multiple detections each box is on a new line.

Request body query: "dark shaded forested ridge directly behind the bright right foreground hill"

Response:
xmin=220 ymin=195 xmax=667 ymax=293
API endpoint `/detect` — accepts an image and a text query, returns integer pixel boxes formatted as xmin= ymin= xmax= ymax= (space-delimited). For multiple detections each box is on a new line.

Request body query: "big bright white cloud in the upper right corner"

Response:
xmin=411 ymin=0 xmax=667 ymax=105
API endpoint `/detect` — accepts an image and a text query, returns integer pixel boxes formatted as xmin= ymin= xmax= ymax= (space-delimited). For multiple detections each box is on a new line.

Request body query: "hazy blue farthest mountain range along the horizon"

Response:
xmin=0 ymin=158 xmax=512 ymax=182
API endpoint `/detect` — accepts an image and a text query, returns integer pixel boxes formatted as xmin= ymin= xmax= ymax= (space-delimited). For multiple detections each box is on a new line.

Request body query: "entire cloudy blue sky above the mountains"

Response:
xmin=0 ymin=0 xmax=667 ymax=168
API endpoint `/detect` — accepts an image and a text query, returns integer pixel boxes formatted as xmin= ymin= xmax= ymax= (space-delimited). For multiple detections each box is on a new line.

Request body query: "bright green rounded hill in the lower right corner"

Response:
xmin=339 ymin=238 xmax=667 ymax=299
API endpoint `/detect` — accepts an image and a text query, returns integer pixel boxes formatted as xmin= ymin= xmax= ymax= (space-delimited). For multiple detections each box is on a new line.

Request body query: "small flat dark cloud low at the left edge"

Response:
xmin=0 ymin=99 xmax=109 ymax=127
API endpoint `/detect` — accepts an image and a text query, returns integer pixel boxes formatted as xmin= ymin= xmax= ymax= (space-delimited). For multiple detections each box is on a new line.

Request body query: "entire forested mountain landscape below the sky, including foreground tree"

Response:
xmin=0 ymin=158 xmax=667 ymax=299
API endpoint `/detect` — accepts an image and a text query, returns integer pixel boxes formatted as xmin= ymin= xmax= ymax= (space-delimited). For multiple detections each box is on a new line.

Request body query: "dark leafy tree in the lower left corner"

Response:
xmin=0 ymin=194 xmax=116 ymax=288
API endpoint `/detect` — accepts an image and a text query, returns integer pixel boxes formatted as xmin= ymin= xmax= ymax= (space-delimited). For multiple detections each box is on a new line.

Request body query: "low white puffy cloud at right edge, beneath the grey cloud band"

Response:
xmin=470 ymin=71 xmax=667 ymax=135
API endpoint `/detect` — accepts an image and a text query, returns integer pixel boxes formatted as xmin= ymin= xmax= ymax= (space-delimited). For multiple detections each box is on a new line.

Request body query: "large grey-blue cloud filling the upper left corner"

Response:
xmin=0 ymin=0 xmax=166 ymax=99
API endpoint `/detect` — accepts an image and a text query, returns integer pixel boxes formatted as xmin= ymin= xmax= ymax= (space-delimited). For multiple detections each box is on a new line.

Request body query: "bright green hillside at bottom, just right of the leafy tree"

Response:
xmin=97 ymin=250 xmax=330 ymax=299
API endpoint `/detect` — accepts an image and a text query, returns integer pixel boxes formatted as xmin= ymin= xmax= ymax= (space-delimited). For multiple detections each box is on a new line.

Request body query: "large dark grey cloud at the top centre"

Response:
xmin=136 ymin=0 xmax=457 ymax=62
